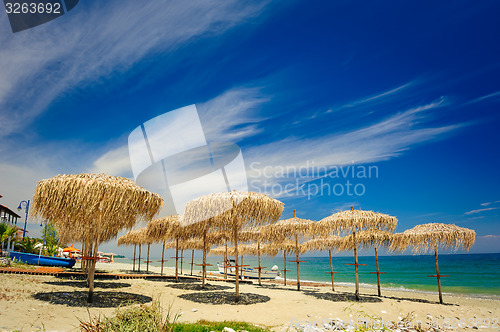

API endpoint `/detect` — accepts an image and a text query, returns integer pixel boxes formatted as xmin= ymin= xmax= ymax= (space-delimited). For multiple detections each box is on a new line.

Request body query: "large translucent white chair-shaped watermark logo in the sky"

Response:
xmin=128 ymin=105 xmax=248 ymax=215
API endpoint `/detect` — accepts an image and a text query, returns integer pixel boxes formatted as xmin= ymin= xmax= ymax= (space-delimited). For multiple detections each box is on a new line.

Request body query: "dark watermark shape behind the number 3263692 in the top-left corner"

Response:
xmin=3 ymin=0 xmax=79 ymax=33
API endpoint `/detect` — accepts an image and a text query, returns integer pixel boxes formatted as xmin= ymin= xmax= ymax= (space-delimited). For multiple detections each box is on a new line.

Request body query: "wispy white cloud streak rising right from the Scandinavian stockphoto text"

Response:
xmin=245 ymin=98 xmax=461 ymax=180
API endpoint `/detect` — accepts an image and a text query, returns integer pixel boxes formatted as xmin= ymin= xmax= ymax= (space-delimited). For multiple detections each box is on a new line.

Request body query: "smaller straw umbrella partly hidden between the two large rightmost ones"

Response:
xmin=342 ymin=228 xmax=394 ymax=296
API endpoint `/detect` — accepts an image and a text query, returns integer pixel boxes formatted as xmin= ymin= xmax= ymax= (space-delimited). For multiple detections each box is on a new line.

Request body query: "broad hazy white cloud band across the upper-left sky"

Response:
xmin=0 ymin=0 xmax=267 ymax=137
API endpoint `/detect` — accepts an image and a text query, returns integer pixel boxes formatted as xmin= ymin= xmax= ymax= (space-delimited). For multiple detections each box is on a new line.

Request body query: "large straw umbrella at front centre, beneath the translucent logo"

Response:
xmin=183 ymin=192 xmax=283 ymax=301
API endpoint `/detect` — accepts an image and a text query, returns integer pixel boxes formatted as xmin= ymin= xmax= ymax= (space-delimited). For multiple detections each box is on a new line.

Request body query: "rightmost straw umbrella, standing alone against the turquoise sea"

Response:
xmin=391 ymin=223 xmax=476 ymax=304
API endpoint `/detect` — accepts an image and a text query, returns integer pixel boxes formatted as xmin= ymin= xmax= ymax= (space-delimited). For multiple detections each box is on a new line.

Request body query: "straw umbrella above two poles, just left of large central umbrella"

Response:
xmin=146 ymin=214 xmax=186 ymax=274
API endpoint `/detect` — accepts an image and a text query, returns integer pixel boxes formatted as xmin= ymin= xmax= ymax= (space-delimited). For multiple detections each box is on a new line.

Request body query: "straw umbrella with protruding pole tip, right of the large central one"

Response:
xmin=264 ymin=210 xmax=315 ymax=290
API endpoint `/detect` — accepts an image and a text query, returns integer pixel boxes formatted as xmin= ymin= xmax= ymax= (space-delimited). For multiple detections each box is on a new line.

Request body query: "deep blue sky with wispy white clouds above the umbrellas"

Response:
xmin=0 ymin=0 xmax=500 ymax=252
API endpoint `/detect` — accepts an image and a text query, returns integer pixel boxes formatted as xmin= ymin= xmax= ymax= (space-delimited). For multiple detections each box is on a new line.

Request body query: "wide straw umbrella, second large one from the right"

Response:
xmin=315 ymin=207 xmax=398 ymax=301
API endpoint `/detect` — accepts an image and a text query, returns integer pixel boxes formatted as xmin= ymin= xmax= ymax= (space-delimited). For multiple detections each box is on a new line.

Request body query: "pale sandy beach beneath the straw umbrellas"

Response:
xmin=0 ymin=263 xmax=500 ymax=331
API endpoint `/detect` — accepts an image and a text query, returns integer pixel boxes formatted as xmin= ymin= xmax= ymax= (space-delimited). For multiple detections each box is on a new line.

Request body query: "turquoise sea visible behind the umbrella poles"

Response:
xmin=117 ymin=251 xmax=500 ymax=298
